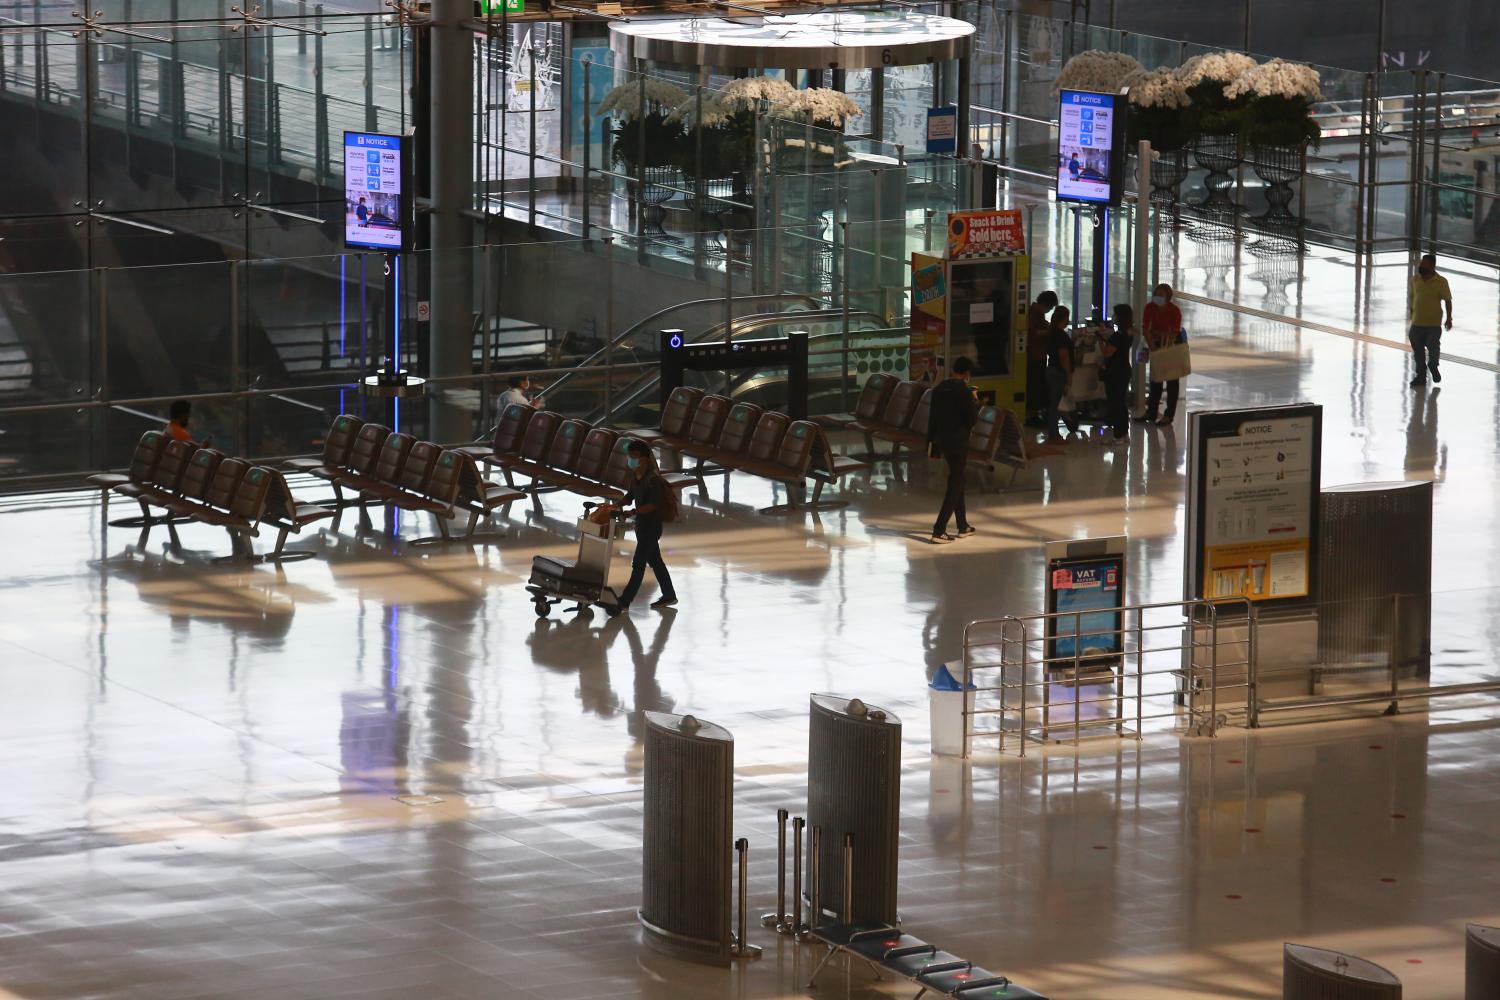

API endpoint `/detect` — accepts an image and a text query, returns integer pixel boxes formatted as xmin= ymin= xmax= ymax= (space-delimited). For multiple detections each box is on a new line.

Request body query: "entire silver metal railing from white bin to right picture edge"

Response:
xmin=963 ymin=594 xmax=1500 ymax=757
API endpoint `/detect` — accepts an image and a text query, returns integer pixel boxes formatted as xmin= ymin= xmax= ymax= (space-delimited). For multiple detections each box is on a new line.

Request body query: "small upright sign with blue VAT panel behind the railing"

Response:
xmin=1047 ymin=555 xmax=1125 ymax=670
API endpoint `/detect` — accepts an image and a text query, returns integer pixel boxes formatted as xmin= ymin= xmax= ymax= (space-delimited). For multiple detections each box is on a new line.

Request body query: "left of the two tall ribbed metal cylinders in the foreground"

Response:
xmin=638 ymin=712 xmax=735 ymax=966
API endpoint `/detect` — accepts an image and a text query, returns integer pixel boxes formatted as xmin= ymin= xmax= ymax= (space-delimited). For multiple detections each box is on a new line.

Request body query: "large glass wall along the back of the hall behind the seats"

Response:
xmin=0 ymin=0 xmax=1500 ymax=481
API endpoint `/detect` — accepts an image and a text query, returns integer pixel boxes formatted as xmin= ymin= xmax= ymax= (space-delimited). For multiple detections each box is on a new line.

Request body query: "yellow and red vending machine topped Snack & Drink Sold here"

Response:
xmin=911 ymin=208 xmax=1031 ymax=420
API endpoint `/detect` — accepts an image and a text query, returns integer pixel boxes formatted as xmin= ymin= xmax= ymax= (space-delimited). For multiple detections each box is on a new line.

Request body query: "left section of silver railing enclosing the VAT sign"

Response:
xmin=963 ymin=598 xmax=1256 ymax=757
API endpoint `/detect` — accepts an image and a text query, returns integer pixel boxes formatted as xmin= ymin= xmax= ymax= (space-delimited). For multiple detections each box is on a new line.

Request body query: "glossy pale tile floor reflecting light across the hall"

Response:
xmin=0 ymin=299 xmax=1500 ymax=1000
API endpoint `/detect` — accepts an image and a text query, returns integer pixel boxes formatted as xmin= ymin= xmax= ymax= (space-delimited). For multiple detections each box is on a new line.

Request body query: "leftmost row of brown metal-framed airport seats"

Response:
xmin=89 ymin=430 xmax=335 ymax=562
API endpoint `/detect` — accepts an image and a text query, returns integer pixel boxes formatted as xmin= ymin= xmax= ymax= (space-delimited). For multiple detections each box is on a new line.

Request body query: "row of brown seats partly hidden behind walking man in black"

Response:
xmin=827 ymin=372 xmax=1026 ymax=488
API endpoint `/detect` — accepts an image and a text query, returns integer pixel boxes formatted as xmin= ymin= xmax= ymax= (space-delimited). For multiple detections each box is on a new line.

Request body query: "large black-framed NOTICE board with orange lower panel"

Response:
xmin=1185 ymin=403 xmax=1323 ymax=606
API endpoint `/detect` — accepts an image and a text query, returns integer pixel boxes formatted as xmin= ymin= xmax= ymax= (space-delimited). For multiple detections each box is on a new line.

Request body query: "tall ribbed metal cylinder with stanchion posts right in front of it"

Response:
xmin=807 ymin=694 xmax=902 ymax=924
